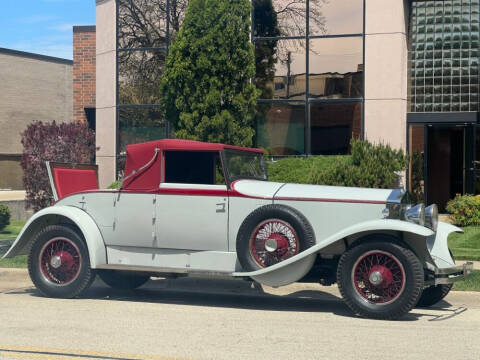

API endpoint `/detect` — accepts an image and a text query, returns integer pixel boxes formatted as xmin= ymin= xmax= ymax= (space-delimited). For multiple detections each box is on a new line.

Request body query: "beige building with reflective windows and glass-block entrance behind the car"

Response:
xmin=96 ymin=0 xmax=480 ymax=207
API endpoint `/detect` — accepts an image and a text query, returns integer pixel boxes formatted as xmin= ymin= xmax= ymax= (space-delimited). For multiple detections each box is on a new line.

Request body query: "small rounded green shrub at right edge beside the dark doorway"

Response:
xmin=446 ymin=195 xmax=480 ymax=226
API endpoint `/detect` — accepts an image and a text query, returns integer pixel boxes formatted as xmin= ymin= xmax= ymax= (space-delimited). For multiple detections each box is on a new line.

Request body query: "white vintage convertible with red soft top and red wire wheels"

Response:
xmin=1 ymin=139 xmax=473 ymax=319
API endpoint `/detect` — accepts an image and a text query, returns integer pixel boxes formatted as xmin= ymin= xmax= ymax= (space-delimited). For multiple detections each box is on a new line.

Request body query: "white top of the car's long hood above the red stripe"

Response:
xmin=232 ymin=180 xmax=393 ymax=204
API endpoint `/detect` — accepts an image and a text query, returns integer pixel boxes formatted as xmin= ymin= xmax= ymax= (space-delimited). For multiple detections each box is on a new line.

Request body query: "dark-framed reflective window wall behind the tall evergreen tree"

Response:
xmin=117 ymin=0 xmax=365 ymax=155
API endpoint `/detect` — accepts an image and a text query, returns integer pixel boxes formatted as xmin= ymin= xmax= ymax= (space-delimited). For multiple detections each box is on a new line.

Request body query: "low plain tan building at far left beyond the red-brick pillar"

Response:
xmin=0 ymin=48 xmax=73 ymax=190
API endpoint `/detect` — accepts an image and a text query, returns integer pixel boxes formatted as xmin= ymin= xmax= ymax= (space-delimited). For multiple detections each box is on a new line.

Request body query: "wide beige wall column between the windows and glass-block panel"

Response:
xmin=365 ymin=0 xmax=408 ymax=150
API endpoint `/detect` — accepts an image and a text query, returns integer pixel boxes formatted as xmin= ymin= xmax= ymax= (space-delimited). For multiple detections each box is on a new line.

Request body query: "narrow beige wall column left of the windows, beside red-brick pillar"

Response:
xmin=96 ymin=0 xmax=116 ymax=188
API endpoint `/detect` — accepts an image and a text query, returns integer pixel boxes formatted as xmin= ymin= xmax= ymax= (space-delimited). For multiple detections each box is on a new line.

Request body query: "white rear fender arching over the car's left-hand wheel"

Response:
xmin=4 ymin=205 xmax=107 ymax=268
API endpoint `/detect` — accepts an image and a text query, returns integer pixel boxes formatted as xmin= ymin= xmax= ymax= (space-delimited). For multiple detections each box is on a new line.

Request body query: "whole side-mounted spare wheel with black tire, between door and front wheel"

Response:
xmin=236 ymin=204 xmax=315 ymax=271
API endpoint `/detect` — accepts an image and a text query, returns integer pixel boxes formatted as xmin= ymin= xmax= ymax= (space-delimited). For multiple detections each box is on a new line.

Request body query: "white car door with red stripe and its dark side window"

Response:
xmin=155 ymin=151 xmax=228 ymax=251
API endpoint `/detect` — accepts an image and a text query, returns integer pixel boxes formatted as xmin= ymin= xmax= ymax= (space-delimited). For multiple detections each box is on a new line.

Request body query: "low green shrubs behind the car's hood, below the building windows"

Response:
xmin=268 ymin=139 xmax=408 ymax=189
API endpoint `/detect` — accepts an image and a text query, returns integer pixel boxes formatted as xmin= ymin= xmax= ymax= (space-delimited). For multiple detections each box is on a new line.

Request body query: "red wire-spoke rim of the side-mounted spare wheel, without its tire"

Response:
xmin=250 ymin=219 xmax=299 ymax=267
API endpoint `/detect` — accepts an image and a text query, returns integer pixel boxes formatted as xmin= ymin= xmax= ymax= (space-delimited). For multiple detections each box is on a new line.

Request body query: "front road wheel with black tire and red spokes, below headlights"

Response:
xmin=337 ymin=241 xmax=424 ymax=320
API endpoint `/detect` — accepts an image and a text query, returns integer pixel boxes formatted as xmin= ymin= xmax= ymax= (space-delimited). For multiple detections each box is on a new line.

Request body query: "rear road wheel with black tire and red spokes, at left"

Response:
xmin=28 ymin=225 xmax=96 ymax=298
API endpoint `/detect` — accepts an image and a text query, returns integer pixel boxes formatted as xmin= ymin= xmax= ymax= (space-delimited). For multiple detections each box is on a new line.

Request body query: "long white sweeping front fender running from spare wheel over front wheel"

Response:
xmin=233 ymin=219 xmax=435 ymax=286
